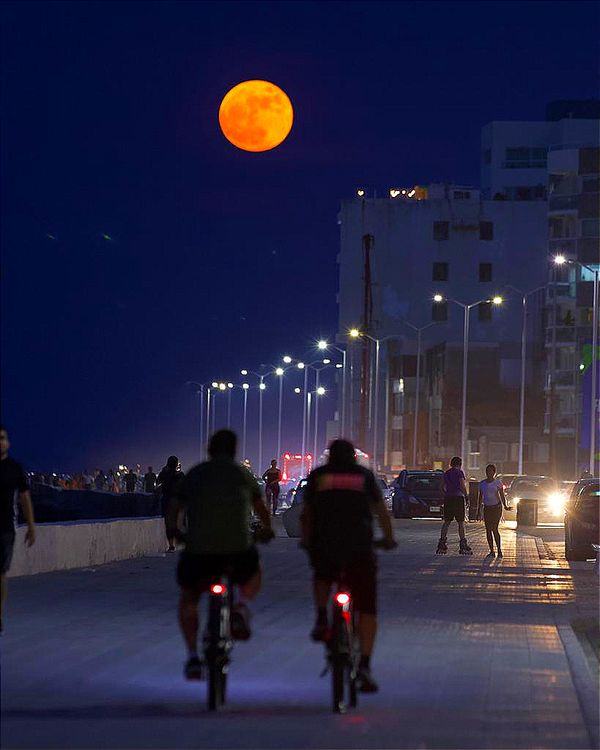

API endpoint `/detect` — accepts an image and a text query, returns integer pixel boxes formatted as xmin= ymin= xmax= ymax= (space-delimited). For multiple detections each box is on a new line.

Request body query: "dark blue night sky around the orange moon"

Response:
xmin=1 ymin=2 xmax=600 ymax=470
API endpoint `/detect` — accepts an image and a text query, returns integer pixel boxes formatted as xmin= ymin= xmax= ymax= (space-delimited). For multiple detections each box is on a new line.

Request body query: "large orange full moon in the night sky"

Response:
xmin=219 ymin=81 xmax=294 ymax=151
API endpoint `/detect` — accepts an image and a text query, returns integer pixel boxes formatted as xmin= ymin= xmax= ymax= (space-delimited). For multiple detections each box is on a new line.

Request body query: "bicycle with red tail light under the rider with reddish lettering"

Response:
xmin=321 ymin=539 xmax=396 ymax=713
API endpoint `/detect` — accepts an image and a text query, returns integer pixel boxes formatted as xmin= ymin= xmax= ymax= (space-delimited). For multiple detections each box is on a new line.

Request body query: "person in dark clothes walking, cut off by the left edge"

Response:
xmin=0 ymin=427 xmax=35 ymax=631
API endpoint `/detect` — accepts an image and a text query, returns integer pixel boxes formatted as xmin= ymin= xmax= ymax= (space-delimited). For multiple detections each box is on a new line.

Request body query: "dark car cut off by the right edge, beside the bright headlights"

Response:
xmin=565 ymin=479 xmax=600 ymax=560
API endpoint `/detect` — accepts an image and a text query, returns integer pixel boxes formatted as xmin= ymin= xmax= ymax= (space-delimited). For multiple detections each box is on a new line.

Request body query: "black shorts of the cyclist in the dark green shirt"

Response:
xmin=177 ymin=547 xmax=260 ymax=593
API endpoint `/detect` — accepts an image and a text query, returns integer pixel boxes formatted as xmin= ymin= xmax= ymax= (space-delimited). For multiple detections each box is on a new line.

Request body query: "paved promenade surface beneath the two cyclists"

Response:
xmin=1 ymin=521 xmax=598 ymax=748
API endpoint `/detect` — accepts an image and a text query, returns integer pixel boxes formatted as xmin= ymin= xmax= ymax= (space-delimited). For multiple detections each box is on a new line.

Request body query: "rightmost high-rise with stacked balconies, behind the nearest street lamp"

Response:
xmin=545 ymin=146 xmax=600 ymax=474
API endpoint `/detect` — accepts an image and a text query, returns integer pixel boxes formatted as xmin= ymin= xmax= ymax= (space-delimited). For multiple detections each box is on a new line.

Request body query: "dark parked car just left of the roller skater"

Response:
xmin=392 ymin=470 xmax=444 ymax=518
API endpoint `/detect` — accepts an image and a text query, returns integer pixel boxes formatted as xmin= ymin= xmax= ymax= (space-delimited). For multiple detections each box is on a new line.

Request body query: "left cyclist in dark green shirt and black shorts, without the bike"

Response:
xmin=169 ymin=430 xmax=272 ymax=680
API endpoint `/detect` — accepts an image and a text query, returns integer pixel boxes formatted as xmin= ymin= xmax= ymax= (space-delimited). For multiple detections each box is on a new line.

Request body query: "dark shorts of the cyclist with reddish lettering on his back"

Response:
xmin=310 ymin=551 xmax=377 ymax=615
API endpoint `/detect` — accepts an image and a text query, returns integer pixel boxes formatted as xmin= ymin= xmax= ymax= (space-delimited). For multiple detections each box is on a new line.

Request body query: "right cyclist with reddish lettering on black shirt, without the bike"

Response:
xmin=301 ymin=440 xmax=396 ymax=693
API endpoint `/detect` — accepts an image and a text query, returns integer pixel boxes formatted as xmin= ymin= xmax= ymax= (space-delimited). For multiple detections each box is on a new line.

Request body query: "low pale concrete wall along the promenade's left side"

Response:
xmin=8 ymin=518 xmax=166 ymax=576
